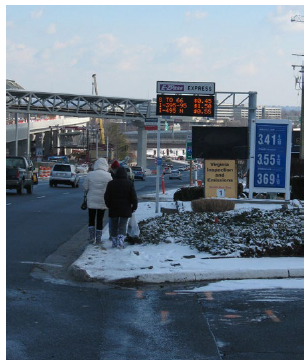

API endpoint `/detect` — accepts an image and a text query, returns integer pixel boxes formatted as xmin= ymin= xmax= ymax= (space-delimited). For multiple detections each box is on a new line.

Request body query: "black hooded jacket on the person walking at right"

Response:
xmin=104 ymin=167 xmax=138 ymax=218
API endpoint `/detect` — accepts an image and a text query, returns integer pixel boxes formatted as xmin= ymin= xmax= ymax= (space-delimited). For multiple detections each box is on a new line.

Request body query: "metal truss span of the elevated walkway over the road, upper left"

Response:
xmin=6 ymin=89 xmax=150 ymax=120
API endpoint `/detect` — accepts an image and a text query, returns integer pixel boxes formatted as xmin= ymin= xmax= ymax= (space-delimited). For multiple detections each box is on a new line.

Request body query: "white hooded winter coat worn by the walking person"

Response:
xmin=83 ymin=158 xmax=112 ymax=209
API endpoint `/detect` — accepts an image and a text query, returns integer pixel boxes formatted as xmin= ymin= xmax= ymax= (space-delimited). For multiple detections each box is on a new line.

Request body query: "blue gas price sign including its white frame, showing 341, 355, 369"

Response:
xmin=251 ymin=120 xmax=292 ymax=199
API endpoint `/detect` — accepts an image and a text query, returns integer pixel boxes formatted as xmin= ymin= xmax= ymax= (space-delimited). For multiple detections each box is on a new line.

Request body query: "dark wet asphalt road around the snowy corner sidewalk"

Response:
xmin=6 ymin=166 xmax=303 ymax=360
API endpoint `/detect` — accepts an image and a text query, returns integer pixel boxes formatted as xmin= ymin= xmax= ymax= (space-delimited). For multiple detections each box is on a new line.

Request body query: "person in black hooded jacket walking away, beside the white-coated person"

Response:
xmin=104 ymin=167 xmax=138 ymax=248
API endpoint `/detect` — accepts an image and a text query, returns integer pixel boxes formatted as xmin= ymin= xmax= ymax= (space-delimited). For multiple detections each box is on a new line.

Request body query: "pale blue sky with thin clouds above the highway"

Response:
xmin=6 ymin=1 xmax=304 ymax=106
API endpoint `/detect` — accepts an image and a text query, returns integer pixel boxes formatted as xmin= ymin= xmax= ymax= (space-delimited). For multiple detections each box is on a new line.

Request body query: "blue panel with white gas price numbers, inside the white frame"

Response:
xmin=254 ymin=123 xmax=288 ymax=188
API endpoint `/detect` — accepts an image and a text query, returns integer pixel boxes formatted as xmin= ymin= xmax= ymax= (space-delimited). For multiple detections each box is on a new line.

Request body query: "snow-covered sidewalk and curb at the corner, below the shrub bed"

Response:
xmin=71 ymin=191 xmax=304 ymax=286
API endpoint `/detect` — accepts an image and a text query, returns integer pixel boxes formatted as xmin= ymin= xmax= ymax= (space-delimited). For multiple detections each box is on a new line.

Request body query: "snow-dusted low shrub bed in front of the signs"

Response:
xmin=139 ymin=207 xmax=304 ymax=257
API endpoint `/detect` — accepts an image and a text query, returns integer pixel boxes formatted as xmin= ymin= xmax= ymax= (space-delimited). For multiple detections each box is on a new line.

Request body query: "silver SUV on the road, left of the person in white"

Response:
xmin=49 ymin=163 xmax=80 ymax=188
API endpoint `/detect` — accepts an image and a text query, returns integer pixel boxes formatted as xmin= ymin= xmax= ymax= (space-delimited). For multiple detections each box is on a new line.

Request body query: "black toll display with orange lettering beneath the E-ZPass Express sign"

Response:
xmin=156 ymin=95 xmax=214 ymax=117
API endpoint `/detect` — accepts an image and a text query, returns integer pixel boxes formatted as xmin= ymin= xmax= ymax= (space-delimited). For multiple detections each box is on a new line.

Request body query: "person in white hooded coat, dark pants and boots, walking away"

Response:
xmin=83 ymin=158 xmax=112 ymax=244
